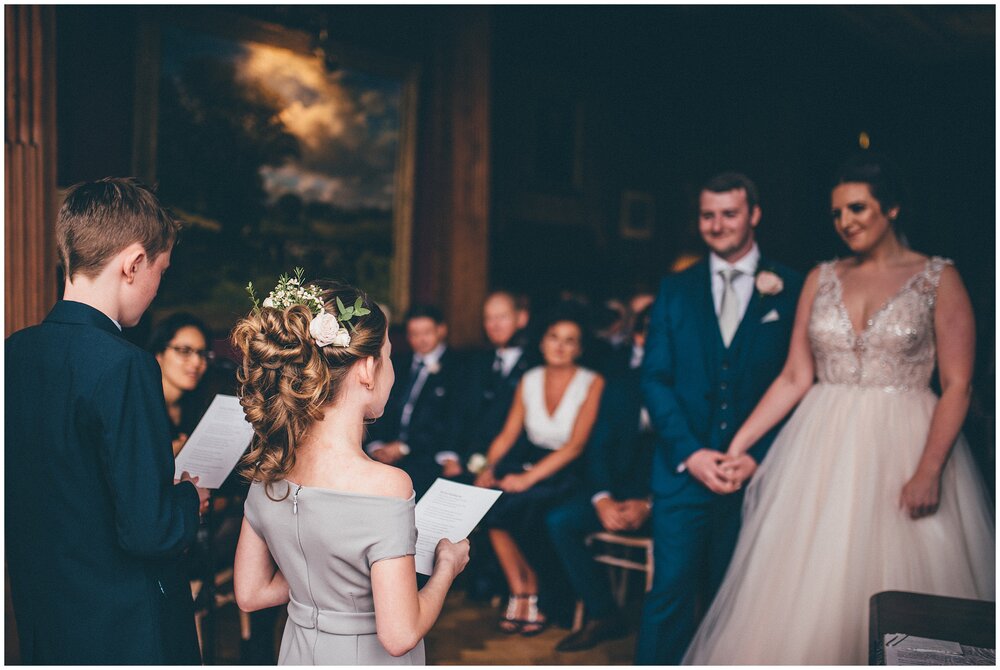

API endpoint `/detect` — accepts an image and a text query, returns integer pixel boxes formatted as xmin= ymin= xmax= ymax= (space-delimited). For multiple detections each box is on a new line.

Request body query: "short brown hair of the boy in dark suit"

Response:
xmin=56 ymin=177 xmax=180 ymax=279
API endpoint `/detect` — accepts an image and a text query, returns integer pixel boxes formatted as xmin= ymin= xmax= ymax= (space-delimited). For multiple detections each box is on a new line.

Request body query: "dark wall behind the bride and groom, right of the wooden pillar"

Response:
xmin=493 ymin=7 xmax=995 ymax=344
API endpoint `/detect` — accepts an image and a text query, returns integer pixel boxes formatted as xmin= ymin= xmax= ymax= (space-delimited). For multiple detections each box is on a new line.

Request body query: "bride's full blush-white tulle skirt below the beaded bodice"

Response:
xmin=684 ymin=384 xmax=995 ymax=665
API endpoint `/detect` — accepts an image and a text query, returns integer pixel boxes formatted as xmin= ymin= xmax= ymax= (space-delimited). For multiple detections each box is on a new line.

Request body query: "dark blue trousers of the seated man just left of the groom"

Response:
xmin=545 ymin=494 xmax=617 ymax=619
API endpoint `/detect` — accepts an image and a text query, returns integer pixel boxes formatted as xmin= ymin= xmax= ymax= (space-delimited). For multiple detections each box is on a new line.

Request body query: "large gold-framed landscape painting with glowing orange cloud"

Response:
xmin=133 ymin=10 xmax=418 ymax=329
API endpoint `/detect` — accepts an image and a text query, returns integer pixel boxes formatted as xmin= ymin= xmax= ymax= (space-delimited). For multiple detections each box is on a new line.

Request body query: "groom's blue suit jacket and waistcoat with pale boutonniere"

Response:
xmin=642 ymin=257 xmax=802 ymax=502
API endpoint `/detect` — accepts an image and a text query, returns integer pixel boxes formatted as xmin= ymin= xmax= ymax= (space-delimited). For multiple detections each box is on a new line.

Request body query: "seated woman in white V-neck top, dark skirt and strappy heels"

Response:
xmin=476 ymin=314 xmax=604 ymax=636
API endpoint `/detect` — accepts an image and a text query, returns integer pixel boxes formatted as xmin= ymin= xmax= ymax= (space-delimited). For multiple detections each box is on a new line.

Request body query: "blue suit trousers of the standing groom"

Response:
xmin=635 ymin=492 xmax=743 ymax=665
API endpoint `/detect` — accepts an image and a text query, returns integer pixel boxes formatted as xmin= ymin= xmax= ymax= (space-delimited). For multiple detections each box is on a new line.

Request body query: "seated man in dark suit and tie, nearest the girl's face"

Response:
xmin=365 ymin=305 xmax=464 ymax=498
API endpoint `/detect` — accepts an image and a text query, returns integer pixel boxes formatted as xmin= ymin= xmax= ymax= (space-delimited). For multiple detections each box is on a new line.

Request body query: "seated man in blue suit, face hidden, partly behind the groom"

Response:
xmin=546 ymin=307 xmax=653 ymax=651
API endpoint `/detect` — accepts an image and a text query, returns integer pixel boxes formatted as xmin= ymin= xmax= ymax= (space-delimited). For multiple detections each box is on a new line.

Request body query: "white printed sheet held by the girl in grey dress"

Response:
xmin=414 ymin=478 xmax=501 ymax=575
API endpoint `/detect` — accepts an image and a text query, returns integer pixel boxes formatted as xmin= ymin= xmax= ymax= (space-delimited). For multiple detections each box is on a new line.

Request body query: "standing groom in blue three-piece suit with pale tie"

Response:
xmin=636 ymin=172 xmax=802 ymax=665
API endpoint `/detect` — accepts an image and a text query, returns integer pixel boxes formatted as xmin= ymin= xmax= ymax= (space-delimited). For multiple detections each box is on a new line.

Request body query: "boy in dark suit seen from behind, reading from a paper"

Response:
xmin=5 ymin=179 xmax=208 ymax=665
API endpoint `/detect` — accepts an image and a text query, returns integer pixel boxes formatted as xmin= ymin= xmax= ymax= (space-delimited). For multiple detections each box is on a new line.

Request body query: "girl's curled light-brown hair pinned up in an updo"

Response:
xmin=232 ymin=281 xmax=386 ymax=487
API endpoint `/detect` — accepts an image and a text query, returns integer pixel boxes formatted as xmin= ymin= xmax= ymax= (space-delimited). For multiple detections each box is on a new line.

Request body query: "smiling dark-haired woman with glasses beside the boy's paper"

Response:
xmin=146 ymin=312 xmax=213 ymax=456
